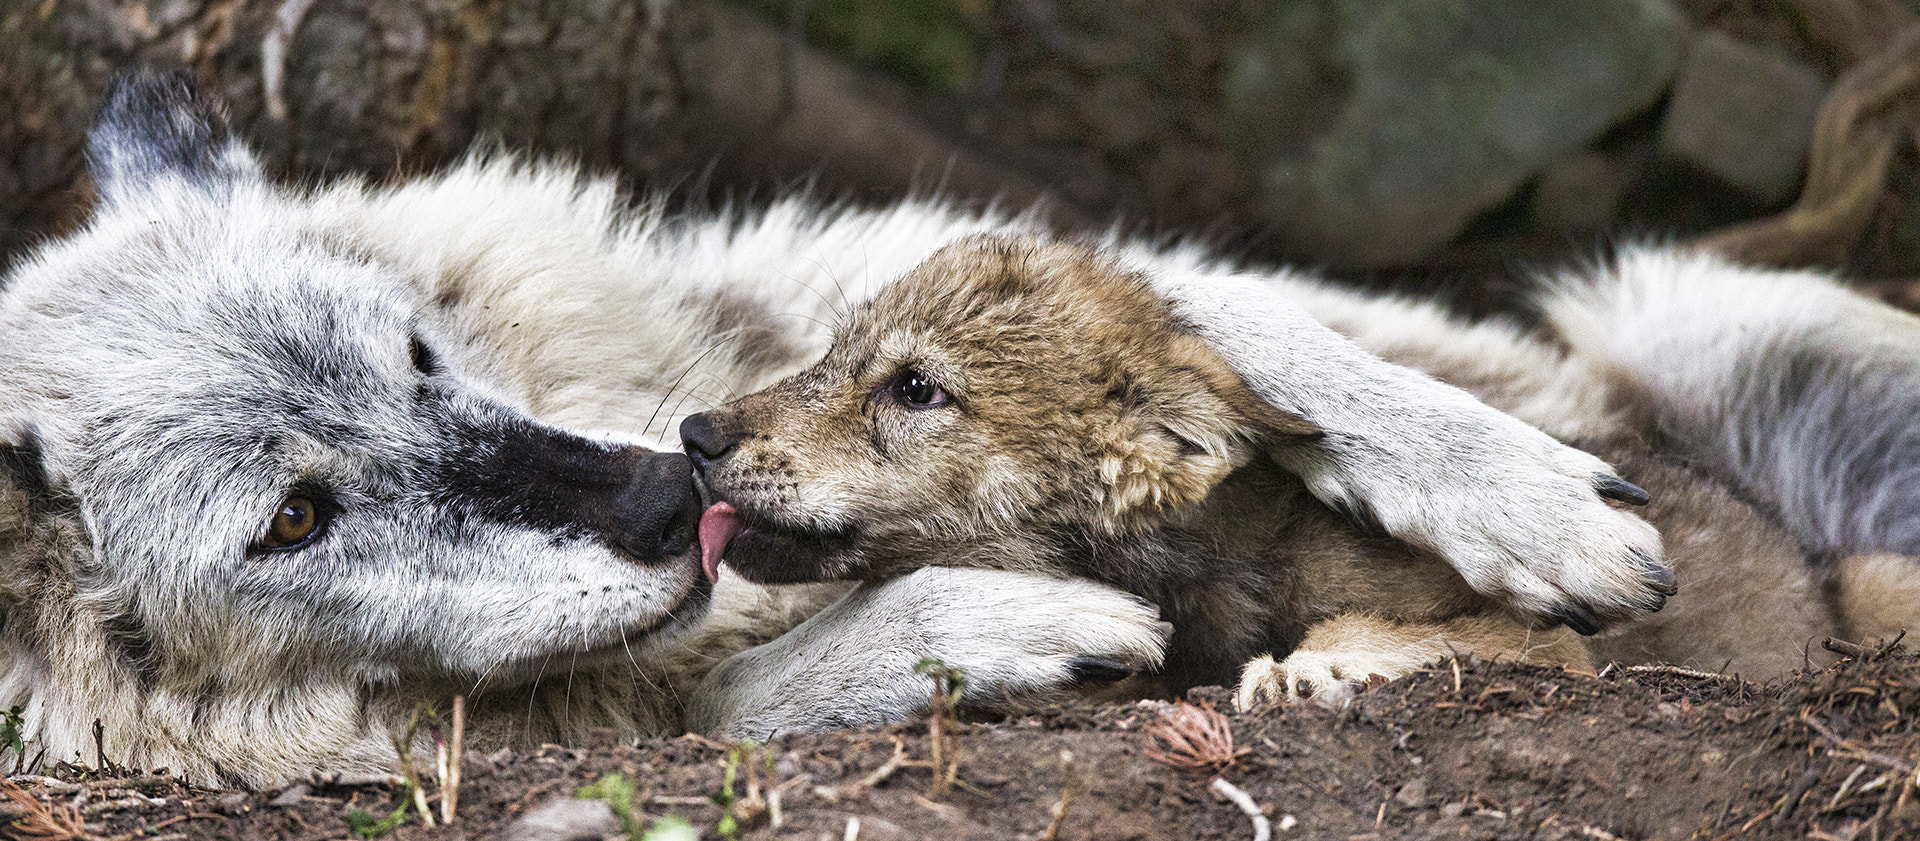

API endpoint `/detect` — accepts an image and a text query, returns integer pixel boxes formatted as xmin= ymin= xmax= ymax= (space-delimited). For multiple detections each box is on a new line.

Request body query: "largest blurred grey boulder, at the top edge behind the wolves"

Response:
xmin=1223 ymin=0 xmax=1688 ymax=267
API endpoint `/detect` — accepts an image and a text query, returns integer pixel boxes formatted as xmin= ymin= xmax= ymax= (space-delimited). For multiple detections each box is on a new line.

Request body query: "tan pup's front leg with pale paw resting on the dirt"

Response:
xmin=1233 ymin=613 xmax=1588 ymax=710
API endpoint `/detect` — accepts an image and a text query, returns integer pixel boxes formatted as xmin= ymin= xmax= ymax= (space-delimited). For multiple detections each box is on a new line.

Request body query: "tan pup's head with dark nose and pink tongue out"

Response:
xmin=682 ymin=236 xmax=1317 ymax=582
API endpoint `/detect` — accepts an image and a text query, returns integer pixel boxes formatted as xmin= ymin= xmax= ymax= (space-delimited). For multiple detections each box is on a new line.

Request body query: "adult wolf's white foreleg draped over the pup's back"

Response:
xmin=1156 ymin=273 xmax=1672 ymax=634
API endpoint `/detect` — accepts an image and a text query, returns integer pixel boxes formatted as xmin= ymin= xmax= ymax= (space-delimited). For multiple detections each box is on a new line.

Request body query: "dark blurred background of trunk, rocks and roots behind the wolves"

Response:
xmin=0 ymin=0 xmax=1920 ymax=313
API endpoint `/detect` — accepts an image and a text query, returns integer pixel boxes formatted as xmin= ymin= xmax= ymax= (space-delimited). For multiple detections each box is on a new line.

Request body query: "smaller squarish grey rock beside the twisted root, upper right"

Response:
xmin=1661 ymin=31 xmax=1828 ymax=204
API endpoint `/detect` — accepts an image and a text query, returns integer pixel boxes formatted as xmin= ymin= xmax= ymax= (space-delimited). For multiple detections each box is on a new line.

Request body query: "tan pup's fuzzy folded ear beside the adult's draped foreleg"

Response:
xmin=1098 ymin=336 xmax=1325 ymax=530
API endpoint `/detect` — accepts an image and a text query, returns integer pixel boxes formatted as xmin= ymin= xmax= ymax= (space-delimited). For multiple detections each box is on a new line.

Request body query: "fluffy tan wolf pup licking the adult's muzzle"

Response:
xmin=684 ymin=238 xmax=1912 ymax=705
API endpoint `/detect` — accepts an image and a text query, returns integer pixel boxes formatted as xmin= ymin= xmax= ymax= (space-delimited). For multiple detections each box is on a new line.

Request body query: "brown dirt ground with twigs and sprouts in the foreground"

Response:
xmin=0 ymin=647 xmax=1920 ymax=841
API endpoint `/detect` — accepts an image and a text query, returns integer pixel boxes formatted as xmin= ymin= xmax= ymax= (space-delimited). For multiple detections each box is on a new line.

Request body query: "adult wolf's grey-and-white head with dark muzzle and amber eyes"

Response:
xmin=0 ymin=75 xmax=708 ymax=775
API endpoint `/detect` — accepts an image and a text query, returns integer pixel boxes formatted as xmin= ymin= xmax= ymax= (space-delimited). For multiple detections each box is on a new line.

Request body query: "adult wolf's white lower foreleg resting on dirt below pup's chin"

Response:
xmin=687 ymin=568 xmax=1171 ymax=739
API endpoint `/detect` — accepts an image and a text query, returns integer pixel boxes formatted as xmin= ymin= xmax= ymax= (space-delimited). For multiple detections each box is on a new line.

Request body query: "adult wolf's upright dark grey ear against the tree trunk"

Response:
xmin=86 ymin=71 xmax=259 ymax=204
